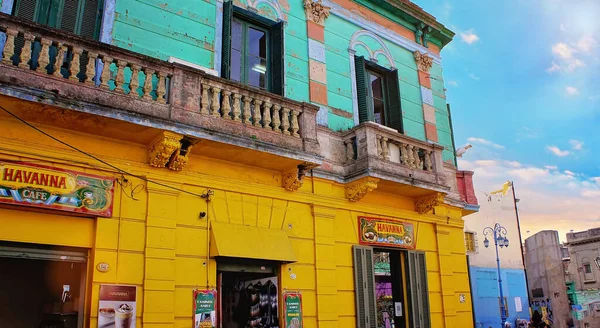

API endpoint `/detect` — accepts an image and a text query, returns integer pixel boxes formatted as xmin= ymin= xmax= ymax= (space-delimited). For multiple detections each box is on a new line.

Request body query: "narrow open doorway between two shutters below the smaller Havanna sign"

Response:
xmin=373 ymin=249 xmax=408 ymax=328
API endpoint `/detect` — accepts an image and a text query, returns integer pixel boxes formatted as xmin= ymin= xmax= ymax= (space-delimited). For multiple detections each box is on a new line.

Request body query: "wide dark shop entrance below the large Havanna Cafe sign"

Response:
xmin=0 ymin=242 xmax=87 ymax=328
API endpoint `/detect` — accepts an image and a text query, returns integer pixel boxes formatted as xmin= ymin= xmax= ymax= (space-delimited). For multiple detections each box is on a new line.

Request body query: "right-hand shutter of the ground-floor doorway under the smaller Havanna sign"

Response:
xmin=408 ymin=251 xmax=431 ymax=328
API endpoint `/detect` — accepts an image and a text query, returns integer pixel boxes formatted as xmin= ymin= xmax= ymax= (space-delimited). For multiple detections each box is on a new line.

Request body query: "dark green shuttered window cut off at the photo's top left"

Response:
xmin=12 ymin=0 xmax=103 ymax=39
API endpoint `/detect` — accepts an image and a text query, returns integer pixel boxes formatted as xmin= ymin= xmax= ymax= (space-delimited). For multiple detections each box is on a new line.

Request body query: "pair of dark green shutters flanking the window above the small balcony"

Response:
xmin=354 ymin=56 xmax=404 ymax=133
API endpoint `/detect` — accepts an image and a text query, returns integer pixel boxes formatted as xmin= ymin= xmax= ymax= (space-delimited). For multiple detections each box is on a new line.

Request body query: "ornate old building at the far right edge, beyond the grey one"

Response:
xmin=566 ymin=228 xmax=600 ymax=327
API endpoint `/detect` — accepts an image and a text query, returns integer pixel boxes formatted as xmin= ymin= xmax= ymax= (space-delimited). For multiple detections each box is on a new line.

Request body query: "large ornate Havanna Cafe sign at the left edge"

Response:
xmin=0 ymin=160 xmax=115 ymax=217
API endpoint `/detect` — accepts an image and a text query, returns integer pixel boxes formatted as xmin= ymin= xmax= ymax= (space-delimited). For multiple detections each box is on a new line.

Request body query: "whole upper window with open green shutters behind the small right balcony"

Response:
xmin=354 ymin=56 xmax=404 ymax=133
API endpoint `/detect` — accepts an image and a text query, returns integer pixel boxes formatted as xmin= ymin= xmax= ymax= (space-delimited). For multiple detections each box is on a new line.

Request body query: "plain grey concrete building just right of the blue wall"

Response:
xmin=524 ymin=230 xmax=571 ymax=328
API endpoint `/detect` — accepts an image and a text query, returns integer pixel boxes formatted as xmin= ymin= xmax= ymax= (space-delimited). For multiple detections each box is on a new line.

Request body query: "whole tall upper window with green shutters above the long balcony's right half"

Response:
xmin=221 ymin=1 xmax=284 ymax=95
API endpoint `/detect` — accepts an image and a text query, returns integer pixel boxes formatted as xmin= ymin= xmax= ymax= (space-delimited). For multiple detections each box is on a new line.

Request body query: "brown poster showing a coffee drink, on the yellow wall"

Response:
xmin=98 ymin=285 xmax=136 ymax=328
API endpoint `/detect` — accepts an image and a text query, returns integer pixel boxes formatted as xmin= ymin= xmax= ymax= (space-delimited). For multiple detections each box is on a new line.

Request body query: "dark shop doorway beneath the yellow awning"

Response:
xmin=217 ymin=259 xmax=280 ymax=328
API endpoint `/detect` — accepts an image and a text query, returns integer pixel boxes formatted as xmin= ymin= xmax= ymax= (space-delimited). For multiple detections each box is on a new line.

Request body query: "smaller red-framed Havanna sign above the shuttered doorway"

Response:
xmin=358 ymin=216 xmax=416 ymax=249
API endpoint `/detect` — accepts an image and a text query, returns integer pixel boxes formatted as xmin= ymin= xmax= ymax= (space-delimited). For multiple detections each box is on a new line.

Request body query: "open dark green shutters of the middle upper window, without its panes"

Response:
xmin=221 ymin=1 xmax=285 ymax=96
